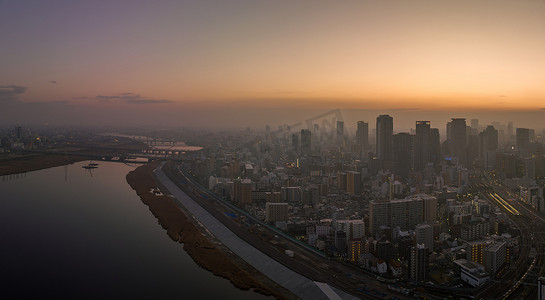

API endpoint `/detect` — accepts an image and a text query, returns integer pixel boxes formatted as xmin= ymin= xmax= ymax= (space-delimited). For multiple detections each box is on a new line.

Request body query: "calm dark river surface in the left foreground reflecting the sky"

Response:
xmin=0 ymin=162 xmax=271 ymax=299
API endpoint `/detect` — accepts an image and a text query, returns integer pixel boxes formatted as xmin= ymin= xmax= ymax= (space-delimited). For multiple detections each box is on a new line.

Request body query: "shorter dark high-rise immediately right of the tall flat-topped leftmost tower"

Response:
xmin=392 ymin=132 xmax=414 ymax=178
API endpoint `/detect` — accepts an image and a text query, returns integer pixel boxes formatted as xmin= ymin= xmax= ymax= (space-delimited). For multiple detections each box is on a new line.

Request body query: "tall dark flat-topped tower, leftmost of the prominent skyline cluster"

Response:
xmin=376 ymin=115 xmax=394 ymax=170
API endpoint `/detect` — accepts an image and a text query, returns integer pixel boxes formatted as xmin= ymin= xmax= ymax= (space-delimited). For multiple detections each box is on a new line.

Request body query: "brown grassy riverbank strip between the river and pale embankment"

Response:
xmin=127 ymin=162 xmax=295 ymax=299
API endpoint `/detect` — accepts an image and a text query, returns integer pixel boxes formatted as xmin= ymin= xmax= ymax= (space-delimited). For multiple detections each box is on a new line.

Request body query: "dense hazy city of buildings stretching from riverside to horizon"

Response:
xmin=0 ymin=114 xmax=545 ymax=299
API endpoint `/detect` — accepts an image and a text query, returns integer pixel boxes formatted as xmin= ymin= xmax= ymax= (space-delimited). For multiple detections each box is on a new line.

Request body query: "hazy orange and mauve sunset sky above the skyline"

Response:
xmin=0 ymin=0 xmax=545 ymax=128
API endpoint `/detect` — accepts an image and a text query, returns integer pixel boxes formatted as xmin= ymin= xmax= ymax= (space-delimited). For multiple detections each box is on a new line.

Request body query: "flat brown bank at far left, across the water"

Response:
xmin=0 ymin=154 xmax=90 ymax=175
